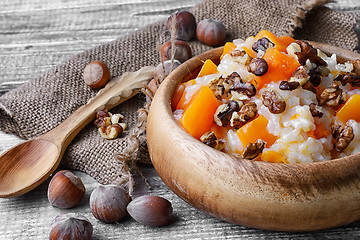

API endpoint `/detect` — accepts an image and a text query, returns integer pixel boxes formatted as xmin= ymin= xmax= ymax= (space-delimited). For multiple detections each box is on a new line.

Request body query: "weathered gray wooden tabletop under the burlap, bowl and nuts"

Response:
xmin=0 ymin=0 xmax=360 ymax=239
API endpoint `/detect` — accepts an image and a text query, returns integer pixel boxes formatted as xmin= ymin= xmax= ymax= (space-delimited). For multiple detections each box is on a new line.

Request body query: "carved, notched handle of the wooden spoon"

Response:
xmin=37 ymin=66 xmax=155 ymax=148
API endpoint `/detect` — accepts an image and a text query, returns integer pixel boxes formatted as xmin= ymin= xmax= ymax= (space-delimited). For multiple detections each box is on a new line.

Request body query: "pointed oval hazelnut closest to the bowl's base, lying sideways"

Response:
xmin=127 ymin=195 xmax=173 ymax=227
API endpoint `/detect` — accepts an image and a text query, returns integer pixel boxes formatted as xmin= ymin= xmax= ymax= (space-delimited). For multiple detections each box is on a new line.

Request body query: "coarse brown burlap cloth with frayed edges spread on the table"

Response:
xmin=0 ymin=0 xmax=360 ymax=188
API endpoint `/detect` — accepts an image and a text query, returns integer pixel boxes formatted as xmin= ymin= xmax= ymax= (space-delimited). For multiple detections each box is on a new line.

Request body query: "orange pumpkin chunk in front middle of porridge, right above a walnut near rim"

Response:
xmin=236 ymin=115 xmax=277 ymax=148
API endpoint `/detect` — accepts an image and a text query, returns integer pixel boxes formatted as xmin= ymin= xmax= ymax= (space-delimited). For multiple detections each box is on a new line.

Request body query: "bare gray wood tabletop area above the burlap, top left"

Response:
xmin=0 ymin=0 xmax=200 ymax=92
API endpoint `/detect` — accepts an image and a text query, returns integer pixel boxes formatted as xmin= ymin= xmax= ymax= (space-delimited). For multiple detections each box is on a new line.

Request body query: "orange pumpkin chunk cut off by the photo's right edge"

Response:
xmin=336 ymin=94 xmax=360 ymax=123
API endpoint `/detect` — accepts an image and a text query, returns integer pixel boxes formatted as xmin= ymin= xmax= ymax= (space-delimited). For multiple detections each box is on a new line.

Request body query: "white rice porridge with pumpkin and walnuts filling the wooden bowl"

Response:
xmin=171 ymin=30 xmax=360 ymax=163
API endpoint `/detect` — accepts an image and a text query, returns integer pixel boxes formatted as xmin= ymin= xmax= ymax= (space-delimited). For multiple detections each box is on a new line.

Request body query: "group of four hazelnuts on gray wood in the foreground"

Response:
xmin=47 ymin=170 xmax=173 ymax=240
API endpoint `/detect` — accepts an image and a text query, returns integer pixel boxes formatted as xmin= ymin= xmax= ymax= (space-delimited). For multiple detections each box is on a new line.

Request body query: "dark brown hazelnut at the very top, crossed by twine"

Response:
xmin=166 ymin=11 xmax=196 ymax=41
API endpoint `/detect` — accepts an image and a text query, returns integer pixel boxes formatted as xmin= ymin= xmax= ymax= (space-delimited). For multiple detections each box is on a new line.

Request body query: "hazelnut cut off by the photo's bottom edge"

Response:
xmin=49 ymin=213 xmax=93 ymax=240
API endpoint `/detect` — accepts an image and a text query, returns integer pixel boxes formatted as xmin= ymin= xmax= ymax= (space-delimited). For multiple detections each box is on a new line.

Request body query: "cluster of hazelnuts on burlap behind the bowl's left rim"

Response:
xmin=159 ymin=10 xmax=226 ymax=75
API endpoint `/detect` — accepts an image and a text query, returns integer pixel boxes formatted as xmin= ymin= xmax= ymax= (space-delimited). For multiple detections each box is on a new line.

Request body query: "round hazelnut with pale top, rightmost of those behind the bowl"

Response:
xmin=196 ymin=19 xmax=226 ymax=47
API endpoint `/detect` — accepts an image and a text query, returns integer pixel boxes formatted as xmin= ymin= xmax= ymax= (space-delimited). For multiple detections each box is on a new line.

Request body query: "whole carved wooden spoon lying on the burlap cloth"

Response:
xmin=0 ymin=67 xmax=154 ymax=198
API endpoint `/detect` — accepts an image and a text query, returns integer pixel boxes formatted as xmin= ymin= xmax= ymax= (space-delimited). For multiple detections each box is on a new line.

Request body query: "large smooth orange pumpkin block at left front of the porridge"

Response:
xmin=180 ymin=86 xmax=220 ymax=139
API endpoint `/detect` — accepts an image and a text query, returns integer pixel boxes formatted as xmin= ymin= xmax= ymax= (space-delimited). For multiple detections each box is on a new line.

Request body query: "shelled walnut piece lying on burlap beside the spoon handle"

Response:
xmin=94 ymin=109 xmax=127 ymax=139
